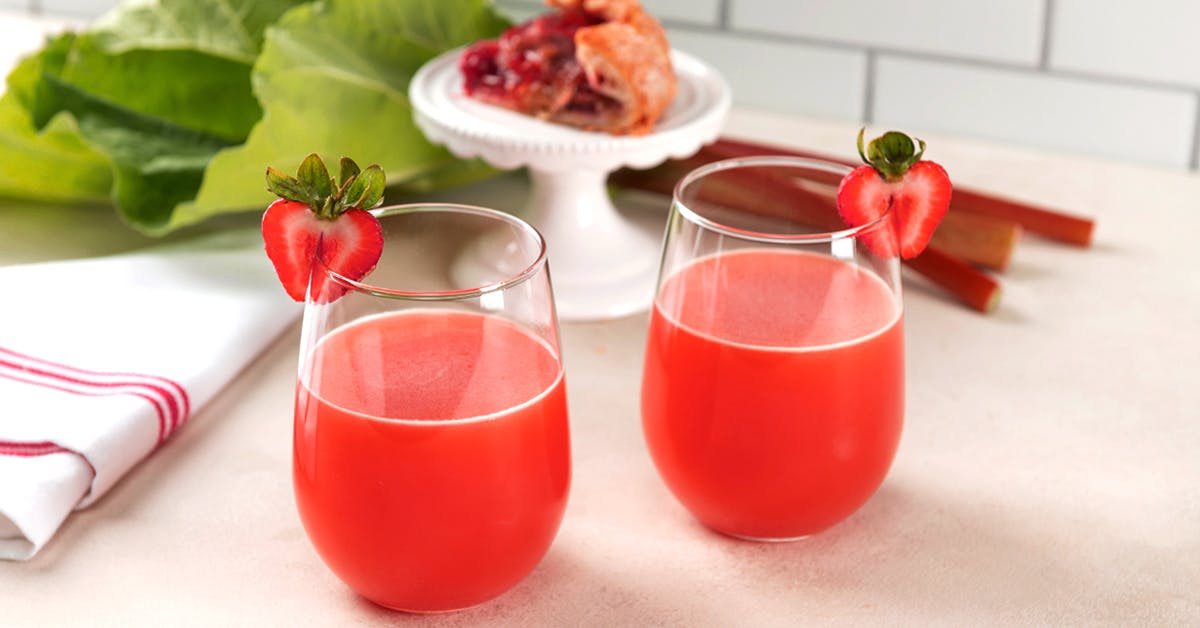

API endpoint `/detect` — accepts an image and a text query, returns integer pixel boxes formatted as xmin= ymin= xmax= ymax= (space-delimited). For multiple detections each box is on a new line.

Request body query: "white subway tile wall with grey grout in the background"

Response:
xmin=9 ymin=0 xmax=1200 ymax=171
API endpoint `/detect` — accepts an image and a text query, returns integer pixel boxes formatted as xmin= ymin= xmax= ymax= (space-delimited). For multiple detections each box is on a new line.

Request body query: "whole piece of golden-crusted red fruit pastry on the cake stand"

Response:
xmin=460 ymin=0 xmax=676 ymax=134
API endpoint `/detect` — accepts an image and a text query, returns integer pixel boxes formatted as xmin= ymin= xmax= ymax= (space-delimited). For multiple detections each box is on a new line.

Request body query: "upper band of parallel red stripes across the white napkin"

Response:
xmin=0 ymin=347 xmax=191 ymax=443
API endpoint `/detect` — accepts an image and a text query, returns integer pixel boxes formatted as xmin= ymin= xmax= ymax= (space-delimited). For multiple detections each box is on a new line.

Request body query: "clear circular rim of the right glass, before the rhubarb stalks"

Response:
xmin=671 ymin=155 xmax=892 ymax=244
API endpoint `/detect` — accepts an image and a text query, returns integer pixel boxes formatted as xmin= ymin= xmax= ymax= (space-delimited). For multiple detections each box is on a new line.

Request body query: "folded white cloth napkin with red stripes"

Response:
xmin=0 ymin=231 xmax=300 ymax=560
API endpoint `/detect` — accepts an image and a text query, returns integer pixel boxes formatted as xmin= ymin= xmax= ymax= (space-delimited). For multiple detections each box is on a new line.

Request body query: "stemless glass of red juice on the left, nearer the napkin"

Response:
xmin=293 ymin=204 xmax=570 ymax=612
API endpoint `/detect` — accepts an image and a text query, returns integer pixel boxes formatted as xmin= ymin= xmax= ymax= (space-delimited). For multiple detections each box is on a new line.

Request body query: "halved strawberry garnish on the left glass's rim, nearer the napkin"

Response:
xmin=263 ymin=154 xmax=384 ymax=303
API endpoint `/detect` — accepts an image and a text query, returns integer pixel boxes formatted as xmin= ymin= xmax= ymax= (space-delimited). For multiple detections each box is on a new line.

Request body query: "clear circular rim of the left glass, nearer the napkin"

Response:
xmin=317 ymin=203 xmax=546 ymax=301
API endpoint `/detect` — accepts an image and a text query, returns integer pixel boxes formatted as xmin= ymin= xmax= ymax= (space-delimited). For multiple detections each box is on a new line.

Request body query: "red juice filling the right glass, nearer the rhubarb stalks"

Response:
xmin=642 ymin=249 xmax=904 ymax=539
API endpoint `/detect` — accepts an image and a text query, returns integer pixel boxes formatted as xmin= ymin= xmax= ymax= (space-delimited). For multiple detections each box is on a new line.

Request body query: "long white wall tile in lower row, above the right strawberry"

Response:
xmin=872 ymin=56 xmax=1196 ymax=168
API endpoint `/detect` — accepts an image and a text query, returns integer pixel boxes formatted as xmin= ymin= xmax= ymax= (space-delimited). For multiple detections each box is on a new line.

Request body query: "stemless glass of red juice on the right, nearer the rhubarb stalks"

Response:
xmin=642 ymin=157 xmax=904 ymax=540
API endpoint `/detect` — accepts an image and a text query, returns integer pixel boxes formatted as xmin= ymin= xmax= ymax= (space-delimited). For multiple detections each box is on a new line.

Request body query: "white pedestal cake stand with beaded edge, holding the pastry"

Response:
xmin=408 ymin=49 xmax=730 ymax=321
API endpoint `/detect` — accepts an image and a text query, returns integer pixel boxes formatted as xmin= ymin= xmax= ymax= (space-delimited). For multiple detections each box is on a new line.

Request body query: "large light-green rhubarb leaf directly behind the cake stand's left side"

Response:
xmin=172 ymin=0 xmax=508 ymax=226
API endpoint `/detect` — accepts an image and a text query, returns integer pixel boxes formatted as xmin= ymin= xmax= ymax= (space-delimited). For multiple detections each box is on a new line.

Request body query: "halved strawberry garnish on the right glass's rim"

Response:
xmin=838 ymin=131 xmax=952 ymax=259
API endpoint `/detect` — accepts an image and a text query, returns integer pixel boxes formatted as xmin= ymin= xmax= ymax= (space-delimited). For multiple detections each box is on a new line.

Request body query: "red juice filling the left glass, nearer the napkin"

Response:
xmin=293 ymin=309 xmax=570 ymax=611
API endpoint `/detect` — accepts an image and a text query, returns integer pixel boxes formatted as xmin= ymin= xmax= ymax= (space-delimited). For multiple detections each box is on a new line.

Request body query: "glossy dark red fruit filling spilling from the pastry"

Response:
xmin=460 ymin=10 xmax=618 ymax=115
